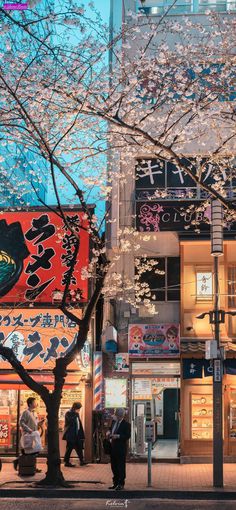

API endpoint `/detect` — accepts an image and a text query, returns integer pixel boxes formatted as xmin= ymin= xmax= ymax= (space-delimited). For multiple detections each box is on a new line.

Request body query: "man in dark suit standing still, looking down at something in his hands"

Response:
xmin=108 ymin=409 xmax=131 ymax=490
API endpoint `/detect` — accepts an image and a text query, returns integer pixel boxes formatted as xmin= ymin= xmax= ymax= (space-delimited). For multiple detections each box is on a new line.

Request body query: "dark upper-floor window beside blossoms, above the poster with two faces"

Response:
xmin=136 ymin=257 xmax=180 ymax=301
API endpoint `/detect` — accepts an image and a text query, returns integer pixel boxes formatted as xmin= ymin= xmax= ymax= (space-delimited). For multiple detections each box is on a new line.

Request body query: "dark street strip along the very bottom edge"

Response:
xmin=0 ymin=498 xmax=235 ymax=510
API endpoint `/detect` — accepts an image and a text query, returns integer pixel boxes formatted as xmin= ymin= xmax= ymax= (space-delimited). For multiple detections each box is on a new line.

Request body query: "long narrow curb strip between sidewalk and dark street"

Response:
xmin=1 ymin=487 xmax=236 ymax=501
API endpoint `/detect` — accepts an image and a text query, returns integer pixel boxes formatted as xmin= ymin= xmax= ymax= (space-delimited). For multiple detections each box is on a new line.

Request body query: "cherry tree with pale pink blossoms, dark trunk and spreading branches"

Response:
xmin=0 ymin=0 xmax=235 ymax=485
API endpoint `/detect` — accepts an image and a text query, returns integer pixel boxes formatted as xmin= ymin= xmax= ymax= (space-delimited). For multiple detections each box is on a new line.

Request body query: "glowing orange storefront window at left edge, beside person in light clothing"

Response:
xmin=0 ymin=390 xmax=18 ymax=453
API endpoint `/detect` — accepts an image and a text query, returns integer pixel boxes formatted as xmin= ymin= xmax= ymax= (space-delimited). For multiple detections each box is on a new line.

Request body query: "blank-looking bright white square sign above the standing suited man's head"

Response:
xmin=105 ymin=378 xmax=127 ymax=408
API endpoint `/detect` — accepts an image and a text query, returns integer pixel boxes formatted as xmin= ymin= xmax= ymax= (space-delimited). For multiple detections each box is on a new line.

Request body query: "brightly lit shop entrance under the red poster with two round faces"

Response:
xmin=131 ymin=362 xmax=180 ymax=460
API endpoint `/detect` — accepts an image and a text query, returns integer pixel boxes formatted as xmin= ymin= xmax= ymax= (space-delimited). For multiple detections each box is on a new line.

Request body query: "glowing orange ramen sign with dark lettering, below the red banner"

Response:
xmin=0 ymin=308 xmax=83 ymax=371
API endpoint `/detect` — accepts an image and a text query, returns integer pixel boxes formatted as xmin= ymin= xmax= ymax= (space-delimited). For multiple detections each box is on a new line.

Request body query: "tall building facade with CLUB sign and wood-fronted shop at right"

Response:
xmin=95 ymin=0 xmax=236 ymax=462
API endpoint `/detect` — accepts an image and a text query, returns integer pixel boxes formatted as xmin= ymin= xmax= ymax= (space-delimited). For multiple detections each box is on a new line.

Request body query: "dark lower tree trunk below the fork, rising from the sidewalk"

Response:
xmin=39 ymin=395 xmax=69 ymax=487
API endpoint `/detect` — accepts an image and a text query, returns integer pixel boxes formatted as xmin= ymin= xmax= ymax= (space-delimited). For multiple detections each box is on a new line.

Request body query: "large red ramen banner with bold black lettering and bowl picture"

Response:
xmin=0 ymin=210 xmax=89 ymax=303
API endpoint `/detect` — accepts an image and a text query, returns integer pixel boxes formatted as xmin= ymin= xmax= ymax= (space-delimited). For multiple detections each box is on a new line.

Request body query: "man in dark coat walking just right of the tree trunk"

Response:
xmin=63 ymin=402 xmax=86 ymax=467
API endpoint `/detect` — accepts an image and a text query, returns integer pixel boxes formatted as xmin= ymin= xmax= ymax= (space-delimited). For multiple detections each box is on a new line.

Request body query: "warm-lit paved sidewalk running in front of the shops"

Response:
xmin=0 ymin=461 xmax=236 ymax=494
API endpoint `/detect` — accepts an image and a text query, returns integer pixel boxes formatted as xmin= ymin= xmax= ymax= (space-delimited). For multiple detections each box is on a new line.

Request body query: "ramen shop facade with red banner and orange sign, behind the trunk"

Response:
xmin=0 ymin=208 xmax=93 ymax=460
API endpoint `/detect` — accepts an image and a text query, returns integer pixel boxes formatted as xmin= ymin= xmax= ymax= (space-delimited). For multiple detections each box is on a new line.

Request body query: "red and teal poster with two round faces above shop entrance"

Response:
xmin=128 ymin=323 xmax=180 ymax=358
